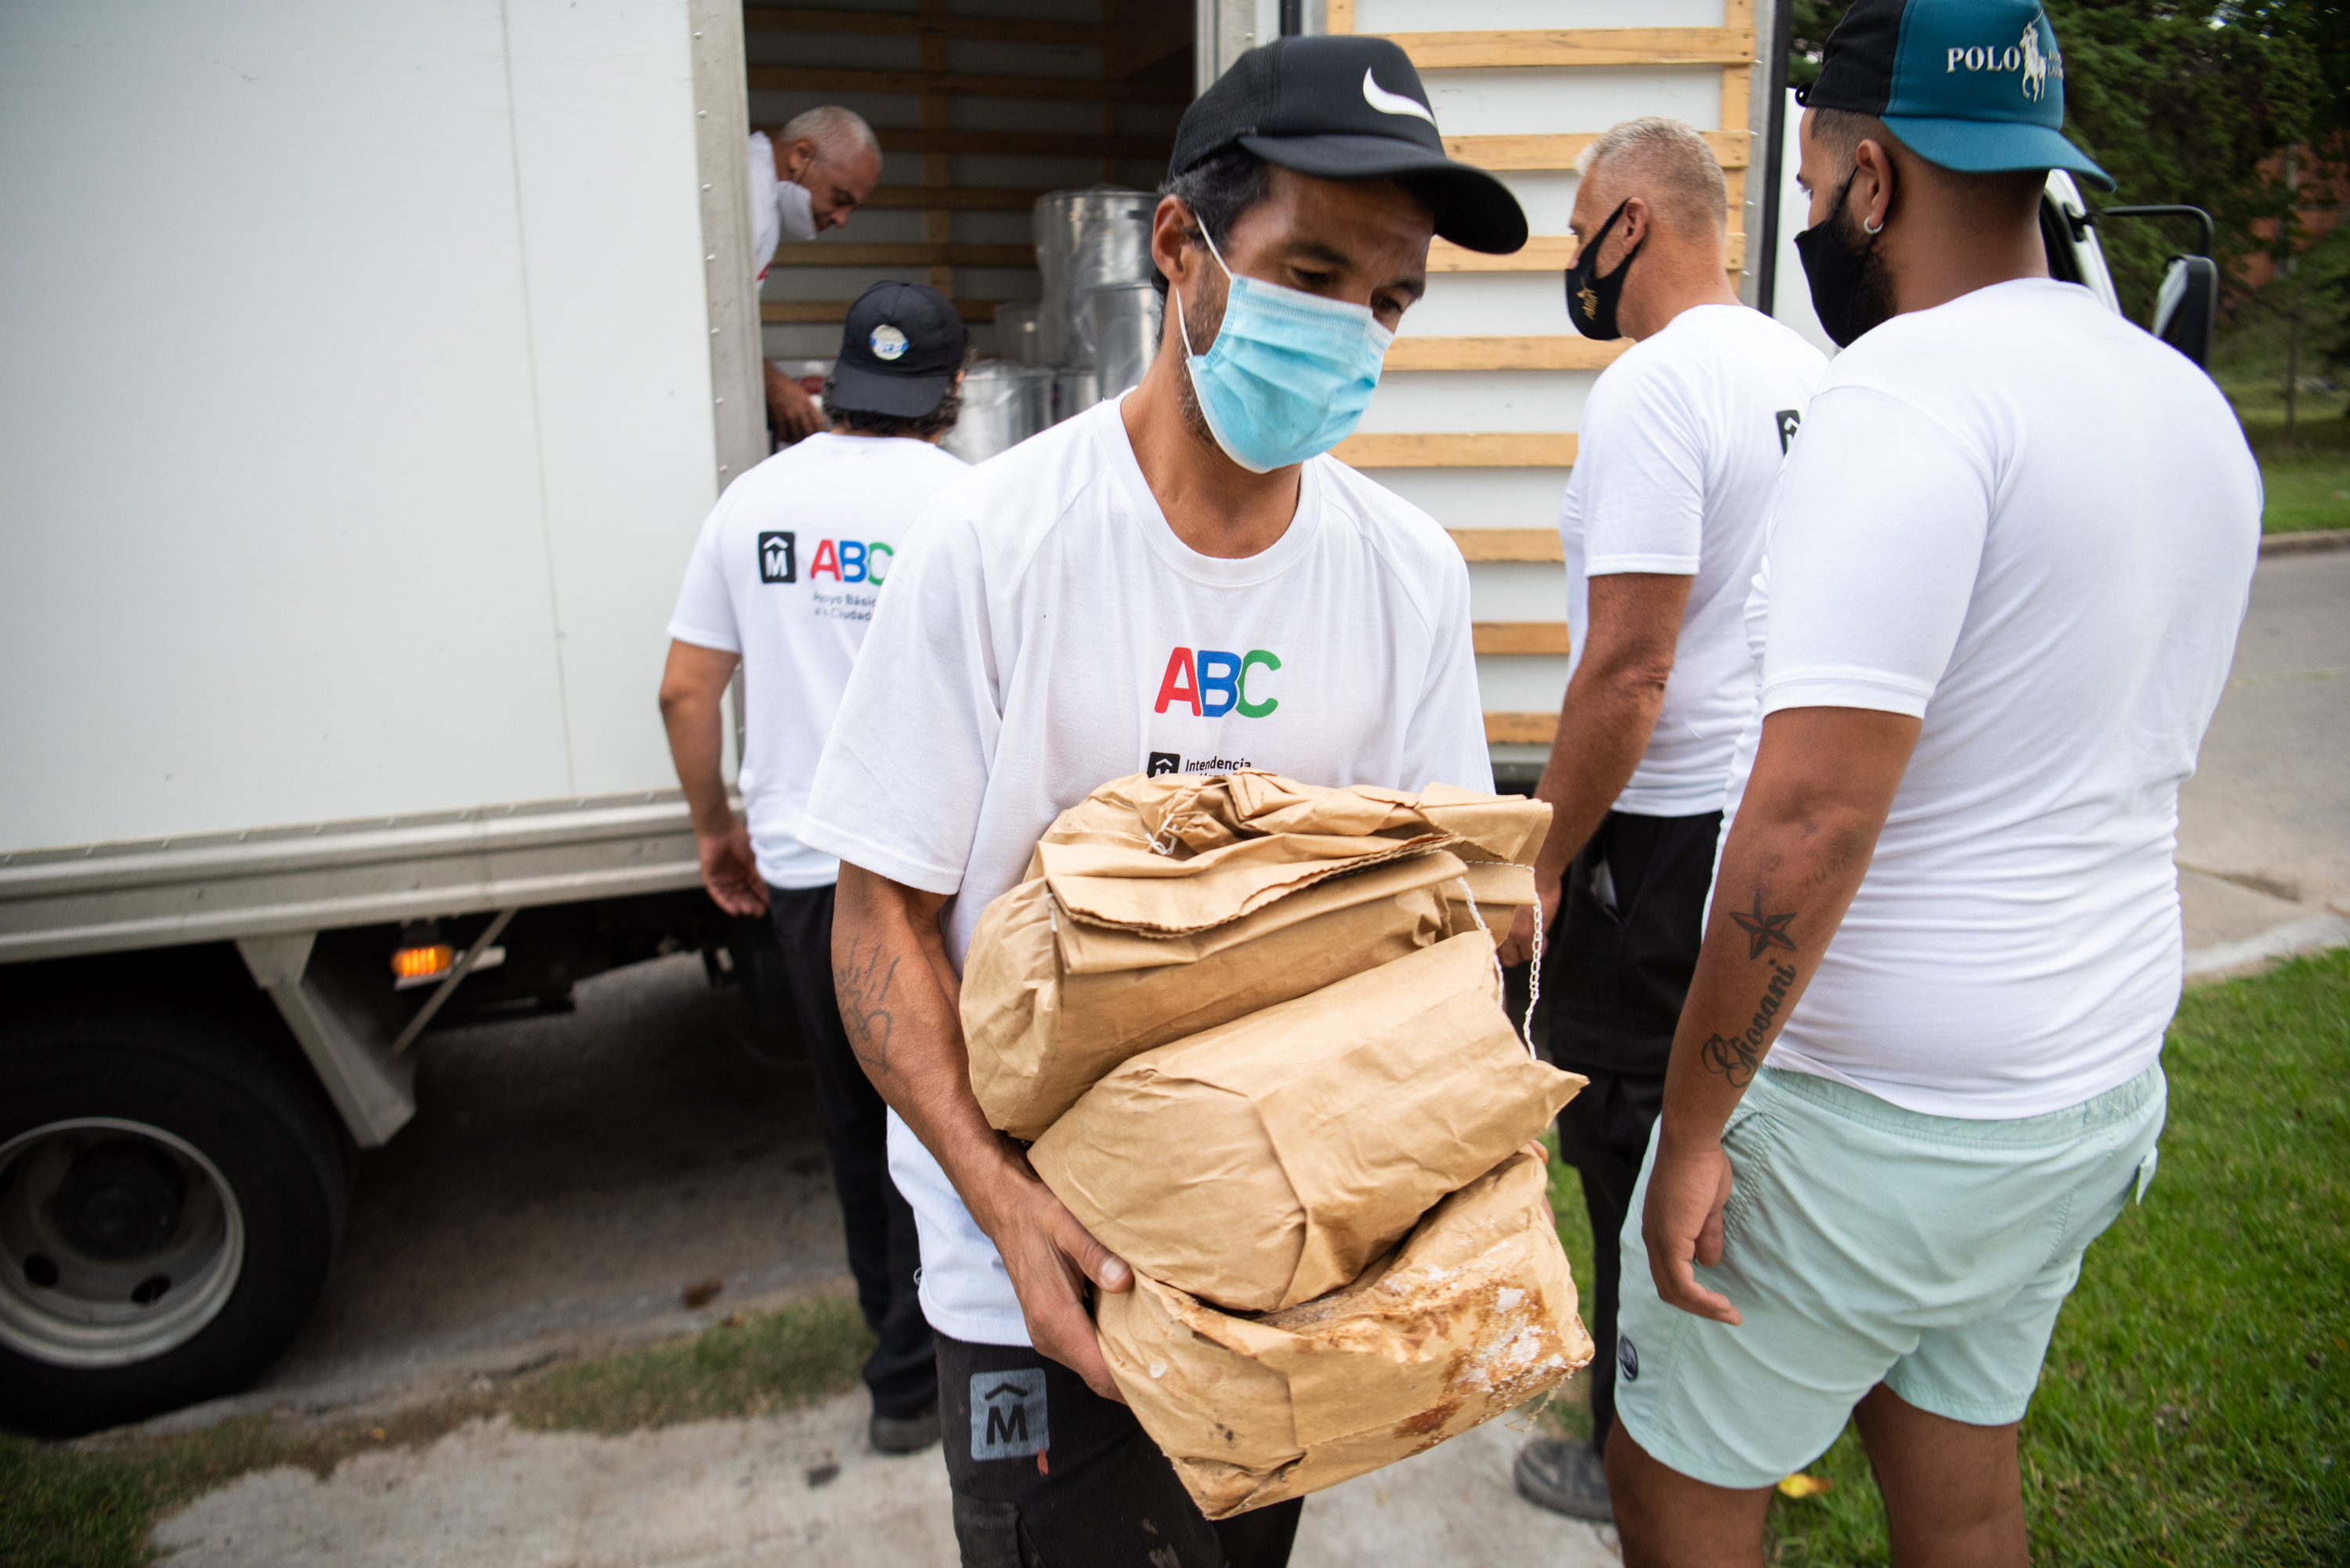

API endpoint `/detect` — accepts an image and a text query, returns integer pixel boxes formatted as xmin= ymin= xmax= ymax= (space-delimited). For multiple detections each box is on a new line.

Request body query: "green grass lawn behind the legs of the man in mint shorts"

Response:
xmin=1551 ymin=950 xmax=2350 ymax=1568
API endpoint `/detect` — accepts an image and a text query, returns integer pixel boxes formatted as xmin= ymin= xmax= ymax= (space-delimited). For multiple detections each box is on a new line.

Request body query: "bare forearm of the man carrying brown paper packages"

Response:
xmin=832 ymin=865 xmax=1036 ymax=1234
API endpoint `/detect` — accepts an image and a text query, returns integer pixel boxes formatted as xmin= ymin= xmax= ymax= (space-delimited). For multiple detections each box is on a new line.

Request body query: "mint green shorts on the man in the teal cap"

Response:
xmin=1617 ymin=1065 xmax=2167 ymax=1488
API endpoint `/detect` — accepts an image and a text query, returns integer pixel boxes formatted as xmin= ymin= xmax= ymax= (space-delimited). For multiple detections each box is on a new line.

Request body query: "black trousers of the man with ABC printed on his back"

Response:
xmin=766 ymin=887 xmax=938 ymax=1415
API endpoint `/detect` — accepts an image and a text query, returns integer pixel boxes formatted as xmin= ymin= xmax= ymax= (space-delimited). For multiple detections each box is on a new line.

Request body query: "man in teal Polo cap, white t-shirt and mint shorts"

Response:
xmin=1607 ymin=0 xmax=2261 ymax=1568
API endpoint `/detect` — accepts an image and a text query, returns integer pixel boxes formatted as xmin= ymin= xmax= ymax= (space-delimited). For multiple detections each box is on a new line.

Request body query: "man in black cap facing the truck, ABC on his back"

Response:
xmin=660 ymin=282 xmax=966 ymax=1453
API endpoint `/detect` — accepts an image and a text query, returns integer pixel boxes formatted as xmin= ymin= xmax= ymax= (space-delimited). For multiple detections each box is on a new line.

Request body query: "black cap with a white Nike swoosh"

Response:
xmin=1168 ymin=35 xmax=1525 ymax=256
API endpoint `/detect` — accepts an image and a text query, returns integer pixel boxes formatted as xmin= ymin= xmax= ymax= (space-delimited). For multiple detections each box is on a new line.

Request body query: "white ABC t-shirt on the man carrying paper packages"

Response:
xmin=801 ymin=399 xmax=1492 ymax=1345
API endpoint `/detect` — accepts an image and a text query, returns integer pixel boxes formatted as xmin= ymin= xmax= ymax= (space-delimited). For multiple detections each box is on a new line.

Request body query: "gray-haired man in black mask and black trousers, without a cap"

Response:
xmin=1504 ymin=117 xmax=1826 ymax=1521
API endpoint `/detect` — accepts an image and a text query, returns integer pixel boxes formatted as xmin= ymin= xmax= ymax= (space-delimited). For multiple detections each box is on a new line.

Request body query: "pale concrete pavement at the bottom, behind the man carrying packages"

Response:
xmin=155 ymin=1394 xmax=1617 ymax=1568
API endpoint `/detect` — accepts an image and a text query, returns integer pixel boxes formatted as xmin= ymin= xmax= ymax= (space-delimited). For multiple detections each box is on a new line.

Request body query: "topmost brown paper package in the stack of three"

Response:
xmin=961 ymin=773 xmax=1549 ymax=1140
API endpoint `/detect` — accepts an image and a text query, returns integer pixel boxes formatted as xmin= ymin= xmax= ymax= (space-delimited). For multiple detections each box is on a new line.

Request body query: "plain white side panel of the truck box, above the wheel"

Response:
xmin=0 ymin=0 xmax=717 ymax=851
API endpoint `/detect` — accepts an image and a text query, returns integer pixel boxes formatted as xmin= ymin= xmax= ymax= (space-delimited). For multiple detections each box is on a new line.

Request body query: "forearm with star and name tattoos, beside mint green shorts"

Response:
xmin=1664 ymin=707 xmax=1918 ymax=1147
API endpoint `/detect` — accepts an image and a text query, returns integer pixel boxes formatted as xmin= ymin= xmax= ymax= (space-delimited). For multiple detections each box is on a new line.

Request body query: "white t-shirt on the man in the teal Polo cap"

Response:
xmin=1725 ymin=280 xmax=2261 ymax=1119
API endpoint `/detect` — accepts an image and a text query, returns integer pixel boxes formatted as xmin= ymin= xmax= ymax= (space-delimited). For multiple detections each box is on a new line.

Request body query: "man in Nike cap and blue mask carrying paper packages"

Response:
xmin=801 ymin=38 xmax=1525 ymax=1568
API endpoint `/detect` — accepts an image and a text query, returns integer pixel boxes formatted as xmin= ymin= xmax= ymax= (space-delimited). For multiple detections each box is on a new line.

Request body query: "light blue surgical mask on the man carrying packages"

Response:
xmin=1170 ymin=228 xmax=1396 ymax=472
